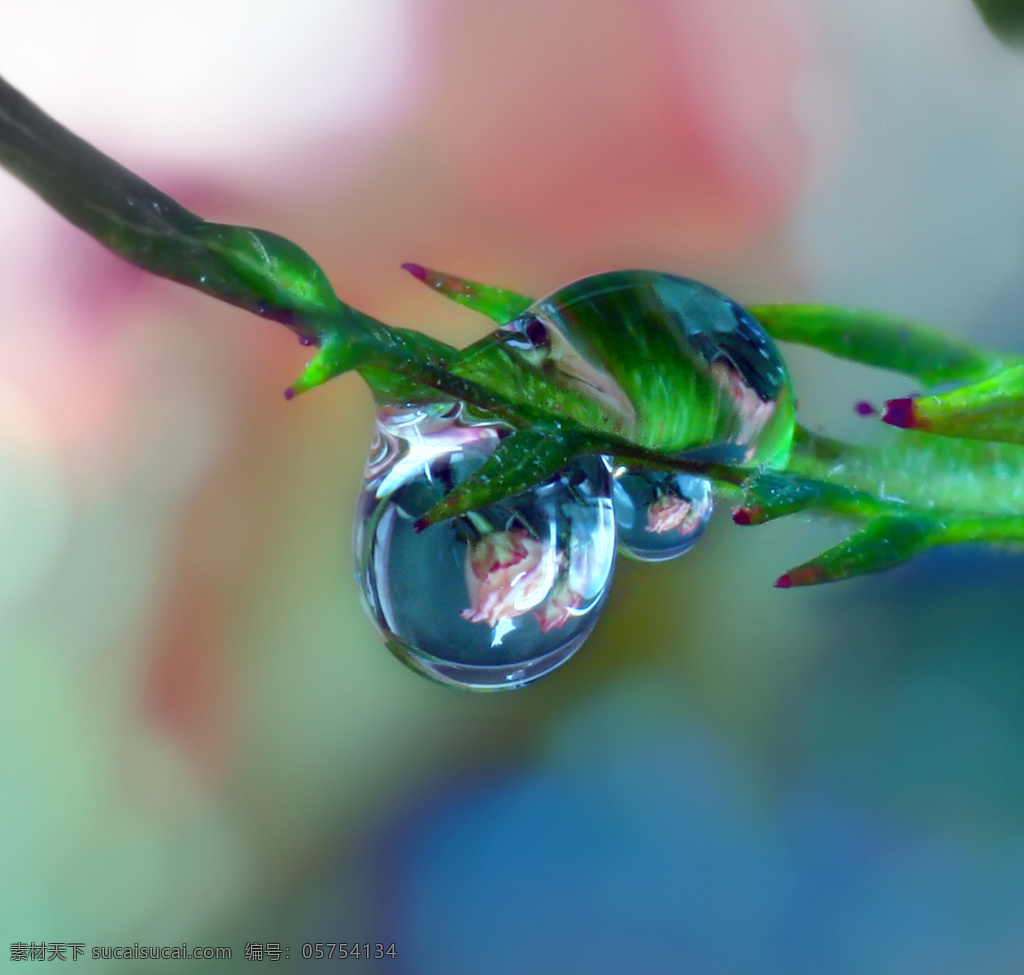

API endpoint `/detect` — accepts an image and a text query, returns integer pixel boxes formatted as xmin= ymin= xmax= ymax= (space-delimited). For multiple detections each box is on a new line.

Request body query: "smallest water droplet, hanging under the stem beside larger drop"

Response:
xmin=611 ymin=467 xmax=715 ymax=562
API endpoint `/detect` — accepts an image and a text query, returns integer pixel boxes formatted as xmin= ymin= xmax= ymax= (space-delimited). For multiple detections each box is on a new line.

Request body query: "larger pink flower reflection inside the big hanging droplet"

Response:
xmin=462 ymin=528 xmax=561 ymax=627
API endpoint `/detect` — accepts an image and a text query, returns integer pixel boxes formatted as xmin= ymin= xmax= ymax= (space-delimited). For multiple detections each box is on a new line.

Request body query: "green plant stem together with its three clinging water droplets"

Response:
xmin=0 ymin=70 xmax=1024 ymax=690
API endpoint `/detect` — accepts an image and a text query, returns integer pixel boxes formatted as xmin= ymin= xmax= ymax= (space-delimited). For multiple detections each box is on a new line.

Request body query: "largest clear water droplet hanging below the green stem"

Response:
xmin=354 ymin=404 xmax=615 ymax=690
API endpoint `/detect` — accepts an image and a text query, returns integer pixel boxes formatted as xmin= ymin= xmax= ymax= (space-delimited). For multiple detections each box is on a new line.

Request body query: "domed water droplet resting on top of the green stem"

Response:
xmin=496 ymin=271 xmax=794 ymax=465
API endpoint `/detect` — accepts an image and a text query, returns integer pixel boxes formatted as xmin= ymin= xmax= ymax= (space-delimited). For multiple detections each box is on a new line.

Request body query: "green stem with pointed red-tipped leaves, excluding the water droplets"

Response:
xmin=0 ymin=72 xmax=1024 ymax=587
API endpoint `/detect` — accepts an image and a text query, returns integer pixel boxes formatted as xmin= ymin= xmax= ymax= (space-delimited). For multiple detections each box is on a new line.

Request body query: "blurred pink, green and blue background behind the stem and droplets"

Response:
xmin=0 ymin=0 xmax=1024 ymax=975
